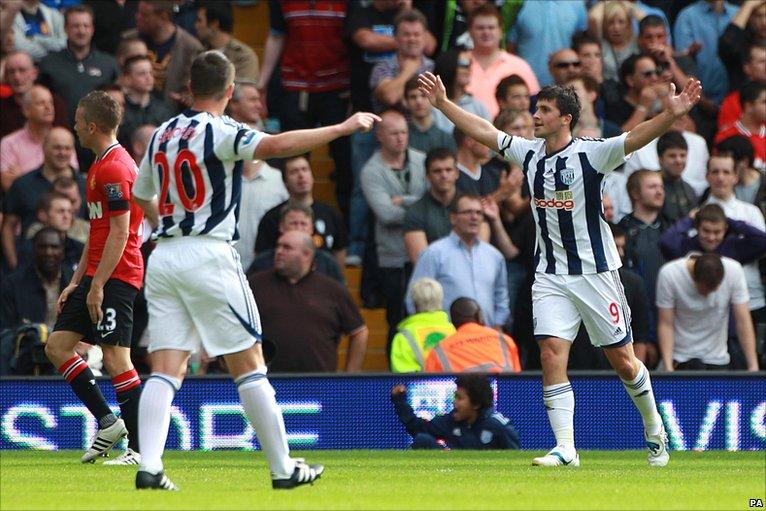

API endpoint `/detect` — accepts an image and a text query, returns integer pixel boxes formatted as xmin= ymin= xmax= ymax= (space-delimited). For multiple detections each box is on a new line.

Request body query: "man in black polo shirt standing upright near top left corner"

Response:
xmin=40 ymin=5 xmax=119 ymax=125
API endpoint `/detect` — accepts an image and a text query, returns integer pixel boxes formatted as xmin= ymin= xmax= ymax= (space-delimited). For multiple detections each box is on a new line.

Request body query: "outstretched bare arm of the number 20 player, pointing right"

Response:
xmin=254 ymin=112 xmax=380 ymax=159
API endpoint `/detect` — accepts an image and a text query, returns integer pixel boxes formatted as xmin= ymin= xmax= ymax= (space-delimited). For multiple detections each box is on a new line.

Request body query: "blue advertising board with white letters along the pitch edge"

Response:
xmin=0 ymin=372 xmax=766 ymax=451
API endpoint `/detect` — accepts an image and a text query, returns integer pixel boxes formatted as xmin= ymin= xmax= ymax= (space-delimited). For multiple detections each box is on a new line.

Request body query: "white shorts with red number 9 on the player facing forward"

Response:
xmin=532 ymin=270 xmax=633 ymax=348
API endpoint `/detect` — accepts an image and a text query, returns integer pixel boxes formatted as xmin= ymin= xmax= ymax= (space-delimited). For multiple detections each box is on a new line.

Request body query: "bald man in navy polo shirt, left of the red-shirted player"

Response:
xmin=2 ymin=128 xmax=85 ymax=268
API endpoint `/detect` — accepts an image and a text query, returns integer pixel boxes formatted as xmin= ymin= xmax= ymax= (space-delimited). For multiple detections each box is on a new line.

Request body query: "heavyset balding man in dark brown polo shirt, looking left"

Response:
xmin=249 ymin=231 xmax=368 ymax=373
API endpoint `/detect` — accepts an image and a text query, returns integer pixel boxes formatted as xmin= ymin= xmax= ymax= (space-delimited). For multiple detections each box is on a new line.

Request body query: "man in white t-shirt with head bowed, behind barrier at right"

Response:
xmin=657 ymin=254 xmax=758 ymax=371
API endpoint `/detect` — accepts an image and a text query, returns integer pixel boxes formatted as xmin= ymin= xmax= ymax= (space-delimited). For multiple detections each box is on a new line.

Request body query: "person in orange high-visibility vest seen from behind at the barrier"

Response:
xmin=425 ymin=297 xmax=521 ymax=373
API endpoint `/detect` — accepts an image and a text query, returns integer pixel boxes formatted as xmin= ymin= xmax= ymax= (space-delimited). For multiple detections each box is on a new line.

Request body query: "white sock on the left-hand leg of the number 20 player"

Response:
xmin=138 ymin=373 xmax=181 ymax=474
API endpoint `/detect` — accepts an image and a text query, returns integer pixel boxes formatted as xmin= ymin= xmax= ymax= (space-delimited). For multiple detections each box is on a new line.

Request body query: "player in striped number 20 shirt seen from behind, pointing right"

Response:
xmin=133 ymin=51 xmax=380 ymax=490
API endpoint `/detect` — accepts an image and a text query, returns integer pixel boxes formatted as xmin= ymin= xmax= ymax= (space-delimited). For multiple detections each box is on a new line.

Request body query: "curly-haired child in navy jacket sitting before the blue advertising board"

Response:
xmin=391 ymin=374 xmax=521 ymax=449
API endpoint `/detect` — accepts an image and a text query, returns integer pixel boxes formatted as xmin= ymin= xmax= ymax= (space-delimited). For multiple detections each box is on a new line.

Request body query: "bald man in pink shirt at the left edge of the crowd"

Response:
xmin=0 ymin=85 xmax=78 ymax=190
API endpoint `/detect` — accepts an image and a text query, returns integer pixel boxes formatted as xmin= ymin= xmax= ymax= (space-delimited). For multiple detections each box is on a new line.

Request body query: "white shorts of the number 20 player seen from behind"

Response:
xmin=145 ymin=236 xmax=261 ymax=357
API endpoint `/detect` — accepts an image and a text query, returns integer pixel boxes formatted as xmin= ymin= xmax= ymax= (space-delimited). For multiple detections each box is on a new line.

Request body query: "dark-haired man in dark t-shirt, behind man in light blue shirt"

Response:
xmin=404 ymin=148 xmax=458 ymax=264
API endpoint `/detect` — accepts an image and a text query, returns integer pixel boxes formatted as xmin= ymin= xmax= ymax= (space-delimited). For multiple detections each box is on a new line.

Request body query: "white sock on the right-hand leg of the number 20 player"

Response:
xmin=235 ymin=368 xmax=295 ymax=478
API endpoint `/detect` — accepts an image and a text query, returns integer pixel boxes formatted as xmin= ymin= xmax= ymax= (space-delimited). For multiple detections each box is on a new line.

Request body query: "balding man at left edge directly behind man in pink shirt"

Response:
xmin=0 ymin=51 xmax=68 ymax=138
